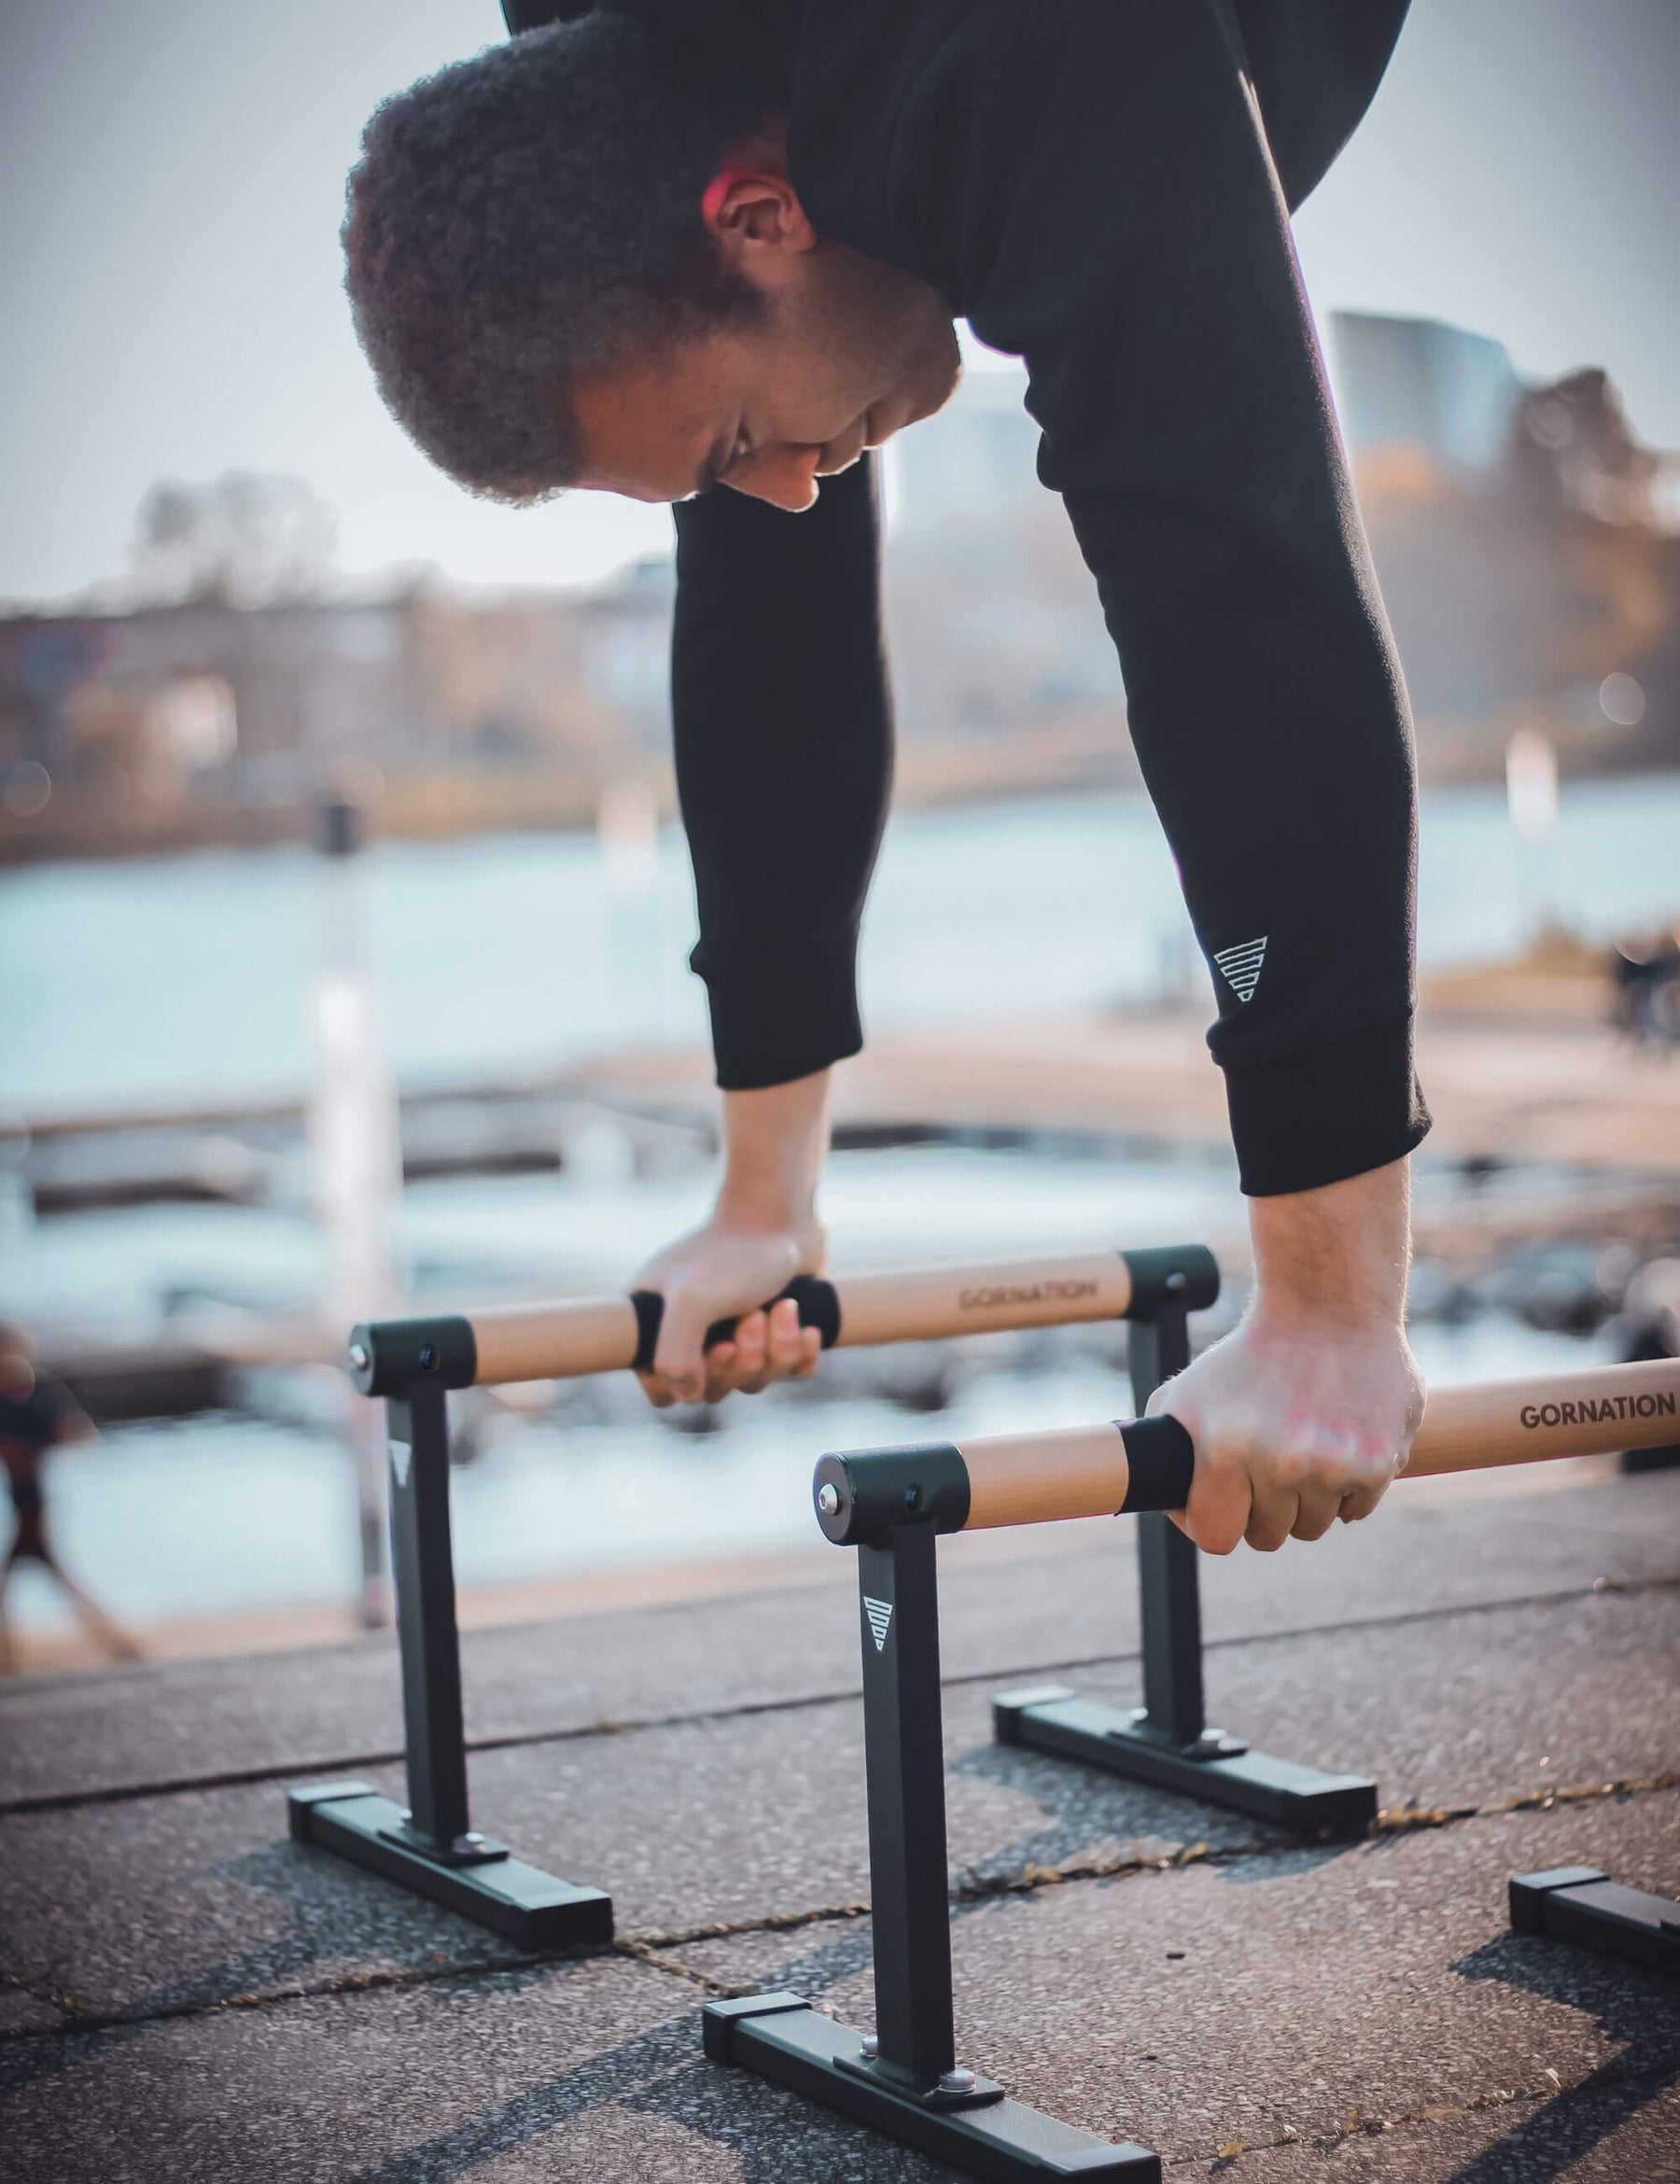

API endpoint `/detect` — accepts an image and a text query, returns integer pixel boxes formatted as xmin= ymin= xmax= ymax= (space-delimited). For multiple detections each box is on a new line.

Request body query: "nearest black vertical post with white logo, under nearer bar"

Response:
xmin=859 ymin=1524 xmax=957 ymax=2090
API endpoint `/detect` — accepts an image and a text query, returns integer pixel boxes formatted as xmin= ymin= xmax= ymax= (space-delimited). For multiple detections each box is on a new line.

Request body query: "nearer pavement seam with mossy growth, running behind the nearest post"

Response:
xmin=0 ymin=1773 xmax=1680 ymax=2044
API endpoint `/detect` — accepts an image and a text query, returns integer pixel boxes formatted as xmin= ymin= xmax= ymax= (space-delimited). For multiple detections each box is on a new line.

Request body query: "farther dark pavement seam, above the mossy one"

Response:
xmin=0 ymin=1576 xmax=1680 ymax=1819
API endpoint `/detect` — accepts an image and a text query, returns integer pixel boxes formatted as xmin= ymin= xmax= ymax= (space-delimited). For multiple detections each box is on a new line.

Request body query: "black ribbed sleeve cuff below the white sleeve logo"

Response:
xmin=1225 ymin=1015 xmax=1429 ymax=1199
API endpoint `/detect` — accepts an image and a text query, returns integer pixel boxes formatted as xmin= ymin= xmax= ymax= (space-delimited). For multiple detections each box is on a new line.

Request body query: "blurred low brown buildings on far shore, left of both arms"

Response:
xmin=0 ymin=572 xmax=668 ymax=854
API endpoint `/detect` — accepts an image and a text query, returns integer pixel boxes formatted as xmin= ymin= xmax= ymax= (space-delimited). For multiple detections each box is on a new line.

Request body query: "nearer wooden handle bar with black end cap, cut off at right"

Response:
xmin=815 ymin=1358 xmax=1680 ymax=1547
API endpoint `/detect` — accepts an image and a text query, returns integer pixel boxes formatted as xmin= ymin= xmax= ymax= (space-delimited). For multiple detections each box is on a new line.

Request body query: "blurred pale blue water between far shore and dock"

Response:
xmin=0 ymin=776 xmax=1680 ymax=1112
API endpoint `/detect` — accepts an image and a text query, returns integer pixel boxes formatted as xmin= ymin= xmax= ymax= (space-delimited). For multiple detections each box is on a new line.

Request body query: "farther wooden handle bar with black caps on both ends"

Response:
xmin=350 ymin=1245 xmax=1219 ymax=1395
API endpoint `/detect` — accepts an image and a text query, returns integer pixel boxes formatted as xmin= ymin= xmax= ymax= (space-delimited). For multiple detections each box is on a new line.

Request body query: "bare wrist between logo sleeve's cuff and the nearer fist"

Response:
xmin=1250 ymin=1160 xmax=1411 ymax=1335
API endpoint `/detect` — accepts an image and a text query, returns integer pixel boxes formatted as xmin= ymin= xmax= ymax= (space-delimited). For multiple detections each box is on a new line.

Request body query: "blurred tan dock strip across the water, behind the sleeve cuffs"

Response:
xmin=11 ymin=1000 xmax=1680 ymax=1212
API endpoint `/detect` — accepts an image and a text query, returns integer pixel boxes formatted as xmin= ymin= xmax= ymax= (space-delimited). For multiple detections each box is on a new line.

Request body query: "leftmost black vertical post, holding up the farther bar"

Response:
xmin=385 ymin=1387 xmax=468 ymax=1856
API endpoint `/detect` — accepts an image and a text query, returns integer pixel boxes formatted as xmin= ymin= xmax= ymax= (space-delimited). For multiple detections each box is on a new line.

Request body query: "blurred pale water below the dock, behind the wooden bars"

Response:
xmin=0 ymin=1147 xmax=1625 ymax=1630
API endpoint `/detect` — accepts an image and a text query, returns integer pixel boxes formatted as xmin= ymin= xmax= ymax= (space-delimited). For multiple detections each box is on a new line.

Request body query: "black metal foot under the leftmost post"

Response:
xmin=287 ymin=1782 xmax=611 ymax=1948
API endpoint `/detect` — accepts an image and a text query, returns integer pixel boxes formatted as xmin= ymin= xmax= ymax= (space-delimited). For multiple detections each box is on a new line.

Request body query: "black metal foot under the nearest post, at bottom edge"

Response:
xmin=701 ymin=1994 xmax=1160 ymax=2184
